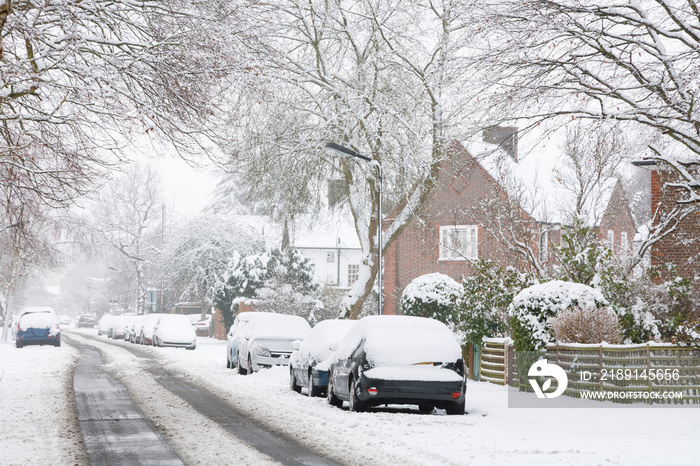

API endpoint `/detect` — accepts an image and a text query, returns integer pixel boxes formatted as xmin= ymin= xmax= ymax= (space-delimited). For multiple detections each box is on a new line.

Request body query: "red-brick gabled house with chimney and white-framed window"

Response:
xmin=384 ymin=129 xmax=636 ymax=314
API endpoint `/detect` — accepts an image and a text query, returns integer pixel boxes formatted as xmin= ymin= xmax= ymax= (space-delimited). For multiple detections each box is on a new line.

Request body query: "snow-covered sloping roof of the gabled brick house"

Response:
xmin=464 ymin=141 xmax=618 ymax=226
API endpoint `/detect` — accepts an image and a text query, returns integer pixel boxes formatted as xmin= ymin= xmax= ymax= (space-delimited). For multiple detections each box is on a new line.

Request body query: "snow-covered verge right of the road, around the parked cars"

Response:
xmin=76 ymin=330 xmax=700 ymax=465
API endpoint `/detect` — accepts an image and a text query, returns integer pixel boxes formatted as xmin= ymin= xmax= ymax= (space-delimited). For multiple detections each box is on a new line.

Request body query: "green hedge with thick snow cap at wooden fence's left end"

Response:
xmin=508 ymin=280 xmax=608 ymax=351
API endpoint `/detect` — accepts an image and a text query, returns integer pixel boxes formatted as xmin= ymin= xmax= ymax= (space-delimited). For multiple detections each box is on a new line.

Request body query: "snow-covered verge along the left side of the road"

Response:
xmin=0 ymin=342 xmax=88 ymax=465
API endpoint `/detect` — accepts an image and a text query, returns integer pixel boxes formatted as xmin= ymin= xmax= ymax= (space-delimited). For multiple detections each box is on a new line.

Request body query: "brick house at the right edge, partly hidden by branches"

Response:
xmin=633 ymin=161 xmax=700 ymax=280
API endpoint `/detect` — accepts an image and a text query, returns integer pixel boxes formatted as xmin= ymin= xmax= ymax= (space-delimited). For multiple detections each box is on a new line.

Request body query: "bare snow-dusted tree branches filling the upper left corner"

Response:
xmin=0 ymin=0 xmax=245 ymax=205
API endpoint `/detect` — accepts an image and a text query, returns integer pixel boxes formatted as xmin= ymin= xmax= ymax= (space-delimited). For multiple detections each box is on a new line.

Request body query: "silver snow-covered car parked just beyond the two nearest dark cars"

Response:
xmin=236 ymin=312 xmax=311 ymax=374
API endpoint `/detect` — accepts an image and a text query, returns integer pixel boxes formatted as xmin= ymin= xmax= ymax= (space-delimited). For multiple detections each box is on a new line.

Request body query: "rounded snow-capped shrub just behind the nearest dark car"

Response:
xmin=401 ymin=273 xmax=462 ymax=328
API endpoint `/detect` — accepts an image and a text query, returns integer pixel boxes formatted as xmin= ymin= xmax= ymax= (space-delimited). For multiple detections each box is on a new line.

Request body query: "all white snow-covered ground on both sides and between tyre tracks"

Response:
xmin=0 ymin=330 xmax=700 ymax=465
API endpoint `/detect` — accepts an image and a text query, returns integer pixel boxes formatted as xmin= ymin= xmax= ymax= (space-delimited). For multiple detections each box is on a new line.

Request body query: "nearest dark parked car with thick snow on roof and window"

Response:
xmin=327 ymin=315 xmax=467 ymax=414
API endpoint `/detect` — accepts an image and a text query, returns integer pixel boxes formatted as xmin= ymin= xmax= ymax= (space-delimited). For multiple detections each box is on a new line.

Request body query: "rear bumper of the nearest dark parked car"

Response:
xmin=359 ymin=375 xmax=467 ymax=407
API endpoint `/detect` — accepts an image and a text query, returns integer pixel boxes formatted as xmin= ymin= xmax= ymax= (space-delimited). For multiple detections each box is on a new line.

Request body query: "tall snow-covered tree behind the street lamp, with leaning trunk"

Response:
xmin=232 ymin=0 xmax=476 ymax=318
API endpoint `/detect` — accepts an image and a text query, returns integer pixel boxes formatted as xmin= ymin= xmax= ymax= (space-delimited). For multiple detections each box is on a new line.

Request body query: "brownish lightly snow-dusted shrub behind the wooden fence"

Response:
xmin=551 ymin=306 xmax=622 ymax=343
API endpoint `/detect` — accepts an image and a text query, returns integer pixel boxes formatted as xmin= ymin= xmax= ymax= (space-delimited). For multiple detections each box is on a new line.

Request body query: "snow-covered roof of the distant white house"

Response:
xmin=290 ymin=209 xmax=360 ymax=249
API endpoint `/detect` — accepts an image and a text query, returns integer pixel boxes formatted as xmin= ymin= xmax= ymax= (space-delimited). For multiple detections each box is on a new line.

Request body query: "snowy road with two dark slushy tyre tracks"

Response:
xmin=64 ymin=334 xmax=339 ymax=466
